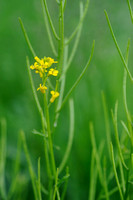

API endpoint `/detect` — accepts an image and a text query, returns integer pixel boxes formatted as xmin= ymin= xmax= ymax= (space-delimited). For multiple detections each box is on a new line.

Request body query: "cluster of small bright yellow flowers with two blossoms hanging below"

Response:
xmin=30 ymin=56 xmax=59 ymax=103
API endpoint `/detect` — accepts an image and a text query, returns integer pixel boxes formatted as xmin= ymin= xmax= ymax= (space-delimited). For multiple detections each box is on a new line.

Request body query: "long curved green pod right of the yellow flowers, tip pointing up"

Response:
xmin=56 ymin=41 xmax=95 ymax=112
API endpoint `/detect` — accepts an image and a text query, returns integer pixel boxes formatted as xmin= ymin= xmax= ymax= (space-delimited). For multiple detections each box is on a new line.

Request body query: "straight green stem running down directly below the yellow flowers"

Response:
xmin=44 ymin=93 xmax=56 ymax=178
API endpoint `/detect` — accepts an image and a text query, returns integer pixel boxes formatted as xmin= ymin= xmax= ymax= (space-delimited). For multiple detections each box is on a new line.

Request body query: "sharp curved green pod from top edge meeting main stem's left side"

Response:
xmin=43 ymin=0 xmax=60 ymax=40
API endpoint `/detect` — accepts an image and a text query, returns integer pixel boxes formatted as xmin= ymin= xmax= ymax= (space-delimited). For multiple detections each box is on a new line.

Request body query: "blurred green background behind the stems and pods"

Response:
xmin=0 ymin=0 xmax=133 ymax=200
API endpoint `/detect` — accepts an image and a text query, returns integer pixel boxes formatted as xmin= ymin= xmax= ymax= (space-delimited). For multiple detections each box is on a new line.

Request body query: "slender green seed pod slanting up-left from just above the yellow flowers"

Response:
xmin=18 ymin=17 xmax=36 ymax=57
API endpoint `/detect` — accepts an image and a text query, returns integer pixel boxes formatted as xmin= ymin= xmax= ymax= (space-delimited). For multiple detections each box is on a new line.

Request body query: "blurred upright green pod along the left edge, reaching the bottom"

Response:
xmin=0 ymin=118 xmax=7 ymax=199
